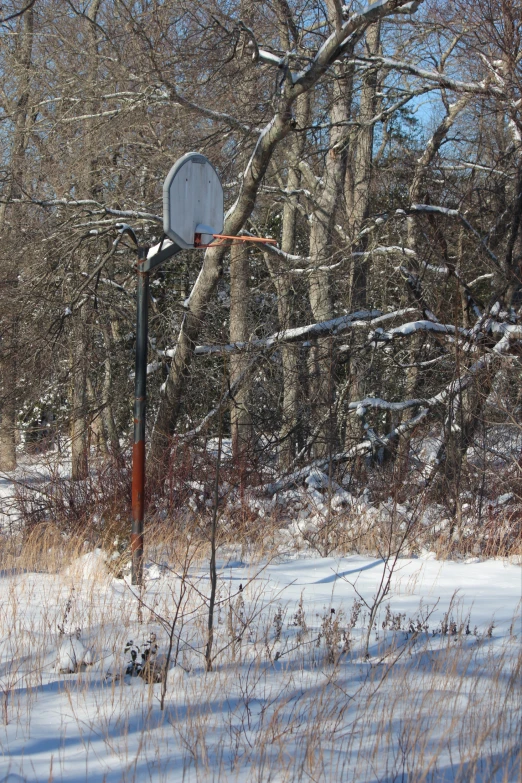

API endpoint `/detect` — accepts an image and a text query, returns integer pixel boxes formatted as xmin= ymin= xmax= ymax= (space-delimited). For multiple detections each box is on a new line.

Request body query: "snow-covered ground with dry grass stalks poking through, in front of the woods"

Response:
xmin=0 ymin=548 xmax=522 ymax=783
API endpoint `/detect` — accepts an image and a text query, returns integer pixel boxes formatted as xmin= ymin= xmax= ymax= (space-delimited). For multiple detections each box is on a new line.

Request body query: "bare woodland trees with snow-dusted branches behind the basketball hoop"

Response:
xmin=0 ymin=0 xmax=522 ymax=540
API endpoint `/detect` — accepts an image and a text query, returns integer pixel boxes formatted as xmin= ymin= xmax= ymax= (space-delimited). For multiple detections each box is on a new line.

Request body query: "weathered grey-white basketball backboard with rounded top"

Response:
xmin=163 ymin=152 xmax=223 ymax=249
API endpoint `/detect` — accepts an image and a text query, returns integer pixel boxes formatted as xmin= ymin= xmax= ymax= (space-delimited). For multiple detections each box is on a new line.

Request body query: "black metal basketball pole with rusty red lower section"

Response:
xmin=131 ymin=248 xmax=149 ymax=585
